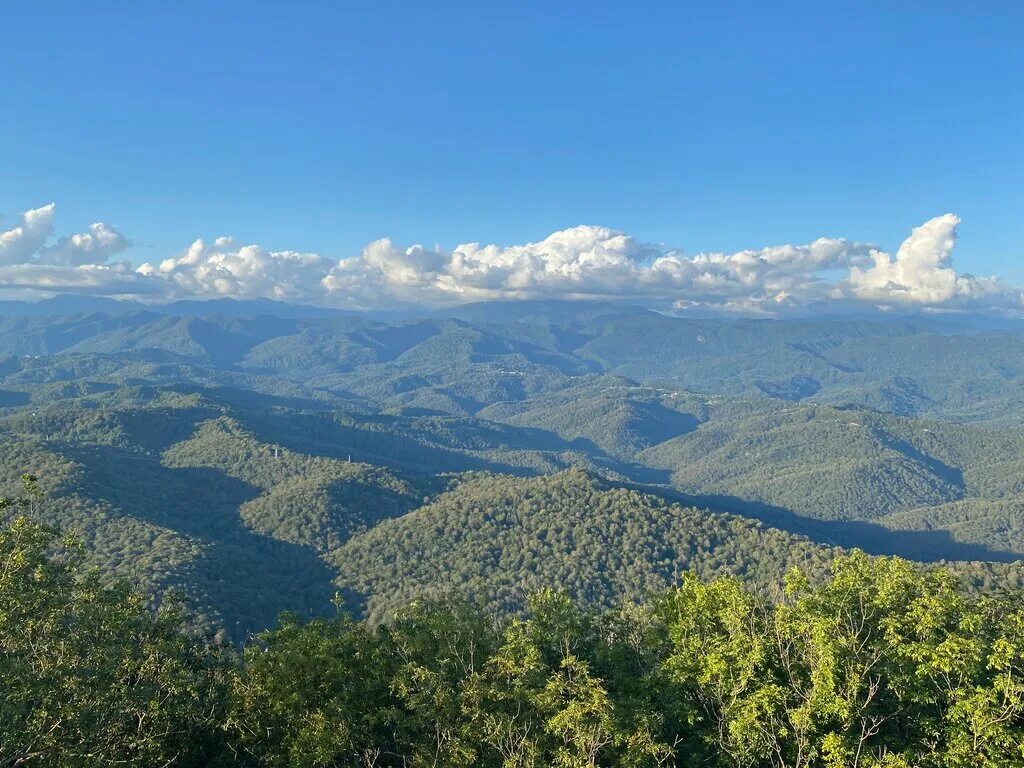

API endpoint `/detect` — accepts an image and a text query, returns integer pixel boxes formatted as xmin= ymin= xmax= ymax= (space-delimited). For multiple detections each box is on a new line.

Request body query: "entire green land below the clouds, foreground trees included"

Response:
xmin=6 ymin=297 xmax=1024 ymax=768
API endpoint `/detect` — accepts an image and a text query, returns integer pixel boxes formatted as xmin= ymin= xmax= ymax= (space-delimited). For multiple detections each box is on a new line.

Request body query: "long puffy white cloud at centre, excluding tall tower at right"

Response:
xmin=323 ymin=226 xmax=870 ymax=305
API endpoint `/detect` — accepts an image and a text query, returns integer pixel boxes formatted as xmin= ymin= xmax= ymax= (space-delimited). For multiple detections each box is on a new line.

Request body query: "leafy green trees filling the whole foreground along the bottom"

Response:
xmin=0 ymin=493 xmax=1024 ymax=768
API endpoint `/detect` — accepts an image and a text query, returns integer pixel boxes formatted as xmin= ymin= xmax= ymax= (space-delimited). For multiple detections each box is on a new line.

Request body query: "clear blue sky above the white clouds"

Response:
xmin=0 ymin=2 xmax=1024 ymax=309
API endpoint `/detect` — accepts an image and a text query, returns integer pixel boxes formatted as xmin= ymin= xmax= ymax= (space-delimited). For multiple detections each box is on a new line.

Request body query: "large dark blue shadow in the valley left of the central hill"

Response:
xmin=61 ymin=446 xmax=335 ymax=640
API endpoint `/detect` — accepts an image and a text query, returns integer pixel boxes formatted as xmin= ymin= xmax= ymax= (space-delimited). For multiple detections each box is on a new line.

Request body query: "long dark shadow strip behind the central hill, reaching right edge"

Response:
xmin=663 ymin=493 xmax=1024 ymax=562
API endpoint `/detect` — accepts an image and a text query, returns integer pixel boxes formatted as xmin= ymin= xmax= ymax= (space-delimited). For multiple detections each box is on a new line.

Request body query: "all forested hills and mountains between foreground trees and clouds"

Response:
xmin=0 ymin=297 xmax=1024 ymax=638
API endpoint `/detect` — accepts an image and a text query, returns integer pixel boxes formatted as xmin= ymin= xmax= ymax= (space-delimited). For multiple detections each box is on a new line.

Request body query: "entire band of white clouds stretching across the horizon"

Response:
xmin=0 ymin=204 xmax=1024 ymax=314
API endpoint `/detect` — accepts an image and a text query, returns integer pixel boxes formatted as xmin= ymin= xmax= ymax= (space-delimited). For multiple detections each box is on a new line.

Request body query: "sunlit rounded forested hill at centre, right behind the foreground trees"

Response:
xmin=331 ymin=470 xmax=831 ymax=621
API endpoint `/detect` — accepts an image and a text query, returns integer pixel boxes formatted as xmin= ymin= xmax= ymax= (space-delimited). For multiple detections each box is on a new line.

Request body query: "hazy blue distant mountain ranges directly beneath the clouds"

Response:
xmin=0 ymin=302 xmax=1024 ymax=425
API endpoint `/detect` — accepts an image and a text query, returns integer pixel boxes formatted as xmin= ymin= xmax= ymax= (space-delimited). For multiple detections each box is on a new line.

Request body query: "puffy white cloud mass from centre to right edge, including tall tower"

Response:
xmin=322 ymin=214 xmax=1021 ymax=314
